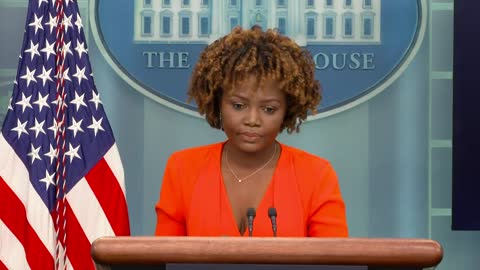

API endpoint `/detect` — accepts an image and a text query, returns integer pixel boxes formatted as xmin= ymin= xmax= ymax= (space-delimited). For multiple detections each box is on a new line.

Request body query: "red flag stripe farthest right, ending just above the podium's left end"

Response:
xmin=85 ymin=158 xmax=130 ymax=236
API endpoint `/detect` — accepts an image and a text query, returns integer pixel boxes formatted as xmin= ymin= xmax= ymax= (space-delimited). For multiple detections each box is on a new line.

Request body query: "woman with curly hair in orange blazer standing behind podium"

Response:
xmin=155 ymin=26 xmax=348 ymax=237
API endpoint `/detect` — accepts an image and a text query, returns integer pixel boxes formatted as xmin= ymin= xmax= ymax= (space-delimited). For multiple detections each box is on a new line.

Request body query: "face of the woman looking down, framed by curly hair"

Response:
xmin=221 ymin=75 xmax=287 ymax=153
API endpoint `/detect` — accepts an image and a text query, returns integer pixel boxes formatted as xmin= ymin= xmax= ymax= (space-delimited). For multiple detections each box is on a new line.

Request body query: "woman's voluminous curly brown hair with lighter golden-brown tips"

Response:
xmin=188 ymin=26 xmax=322 ymax=133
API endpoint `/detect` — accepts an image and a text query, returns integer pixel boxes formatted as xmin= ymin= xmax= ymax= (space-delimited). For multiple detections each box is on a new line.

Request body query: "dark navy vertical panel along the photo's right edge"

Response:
xmin=452 ymin=0 xmax=480 ymax=230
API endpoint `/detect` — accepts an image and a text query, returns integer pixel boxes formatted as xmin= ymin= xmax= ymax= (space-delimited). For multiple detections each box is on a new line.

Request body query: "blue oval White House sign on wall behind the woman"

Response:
xmin=90 ymin=0 xmax=426 ymax=118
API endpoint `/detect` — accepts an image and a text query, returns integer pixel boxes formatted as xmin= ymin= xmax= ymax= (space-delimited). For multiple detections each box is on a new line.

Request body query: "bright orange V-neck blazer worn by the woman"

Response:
xmin=155 ymin=142 xmax=348 ymax=237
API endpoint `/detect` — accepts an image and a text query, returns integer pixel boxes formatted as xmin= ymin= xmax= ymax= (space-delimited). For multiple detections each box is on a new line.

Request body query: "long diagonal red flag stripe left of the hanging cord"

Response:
xmin=0 ymin=176 xmax=53 ymax=269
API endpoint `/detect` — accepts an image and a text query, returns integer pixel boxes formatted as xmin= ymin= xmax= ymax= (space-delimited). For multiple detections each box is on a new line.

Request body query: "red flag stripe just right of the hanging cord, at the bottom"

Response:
xmin=66 ymin=202 xmax=95 ymax=270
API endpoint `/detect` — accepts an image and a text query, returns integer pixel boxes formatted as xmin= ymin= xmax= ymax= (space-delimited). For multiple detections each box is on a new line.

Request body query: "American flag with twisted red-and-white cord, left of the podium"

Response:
xmin=0 ymin=0 xmax=130 ymax=269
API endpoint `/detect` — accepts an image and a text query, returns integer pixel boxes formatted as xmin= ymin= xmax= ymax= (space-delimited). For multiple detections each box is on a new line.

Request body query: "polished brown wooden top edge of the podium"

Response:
xmin=91 ymin=236 xmax=443 ymax=270
